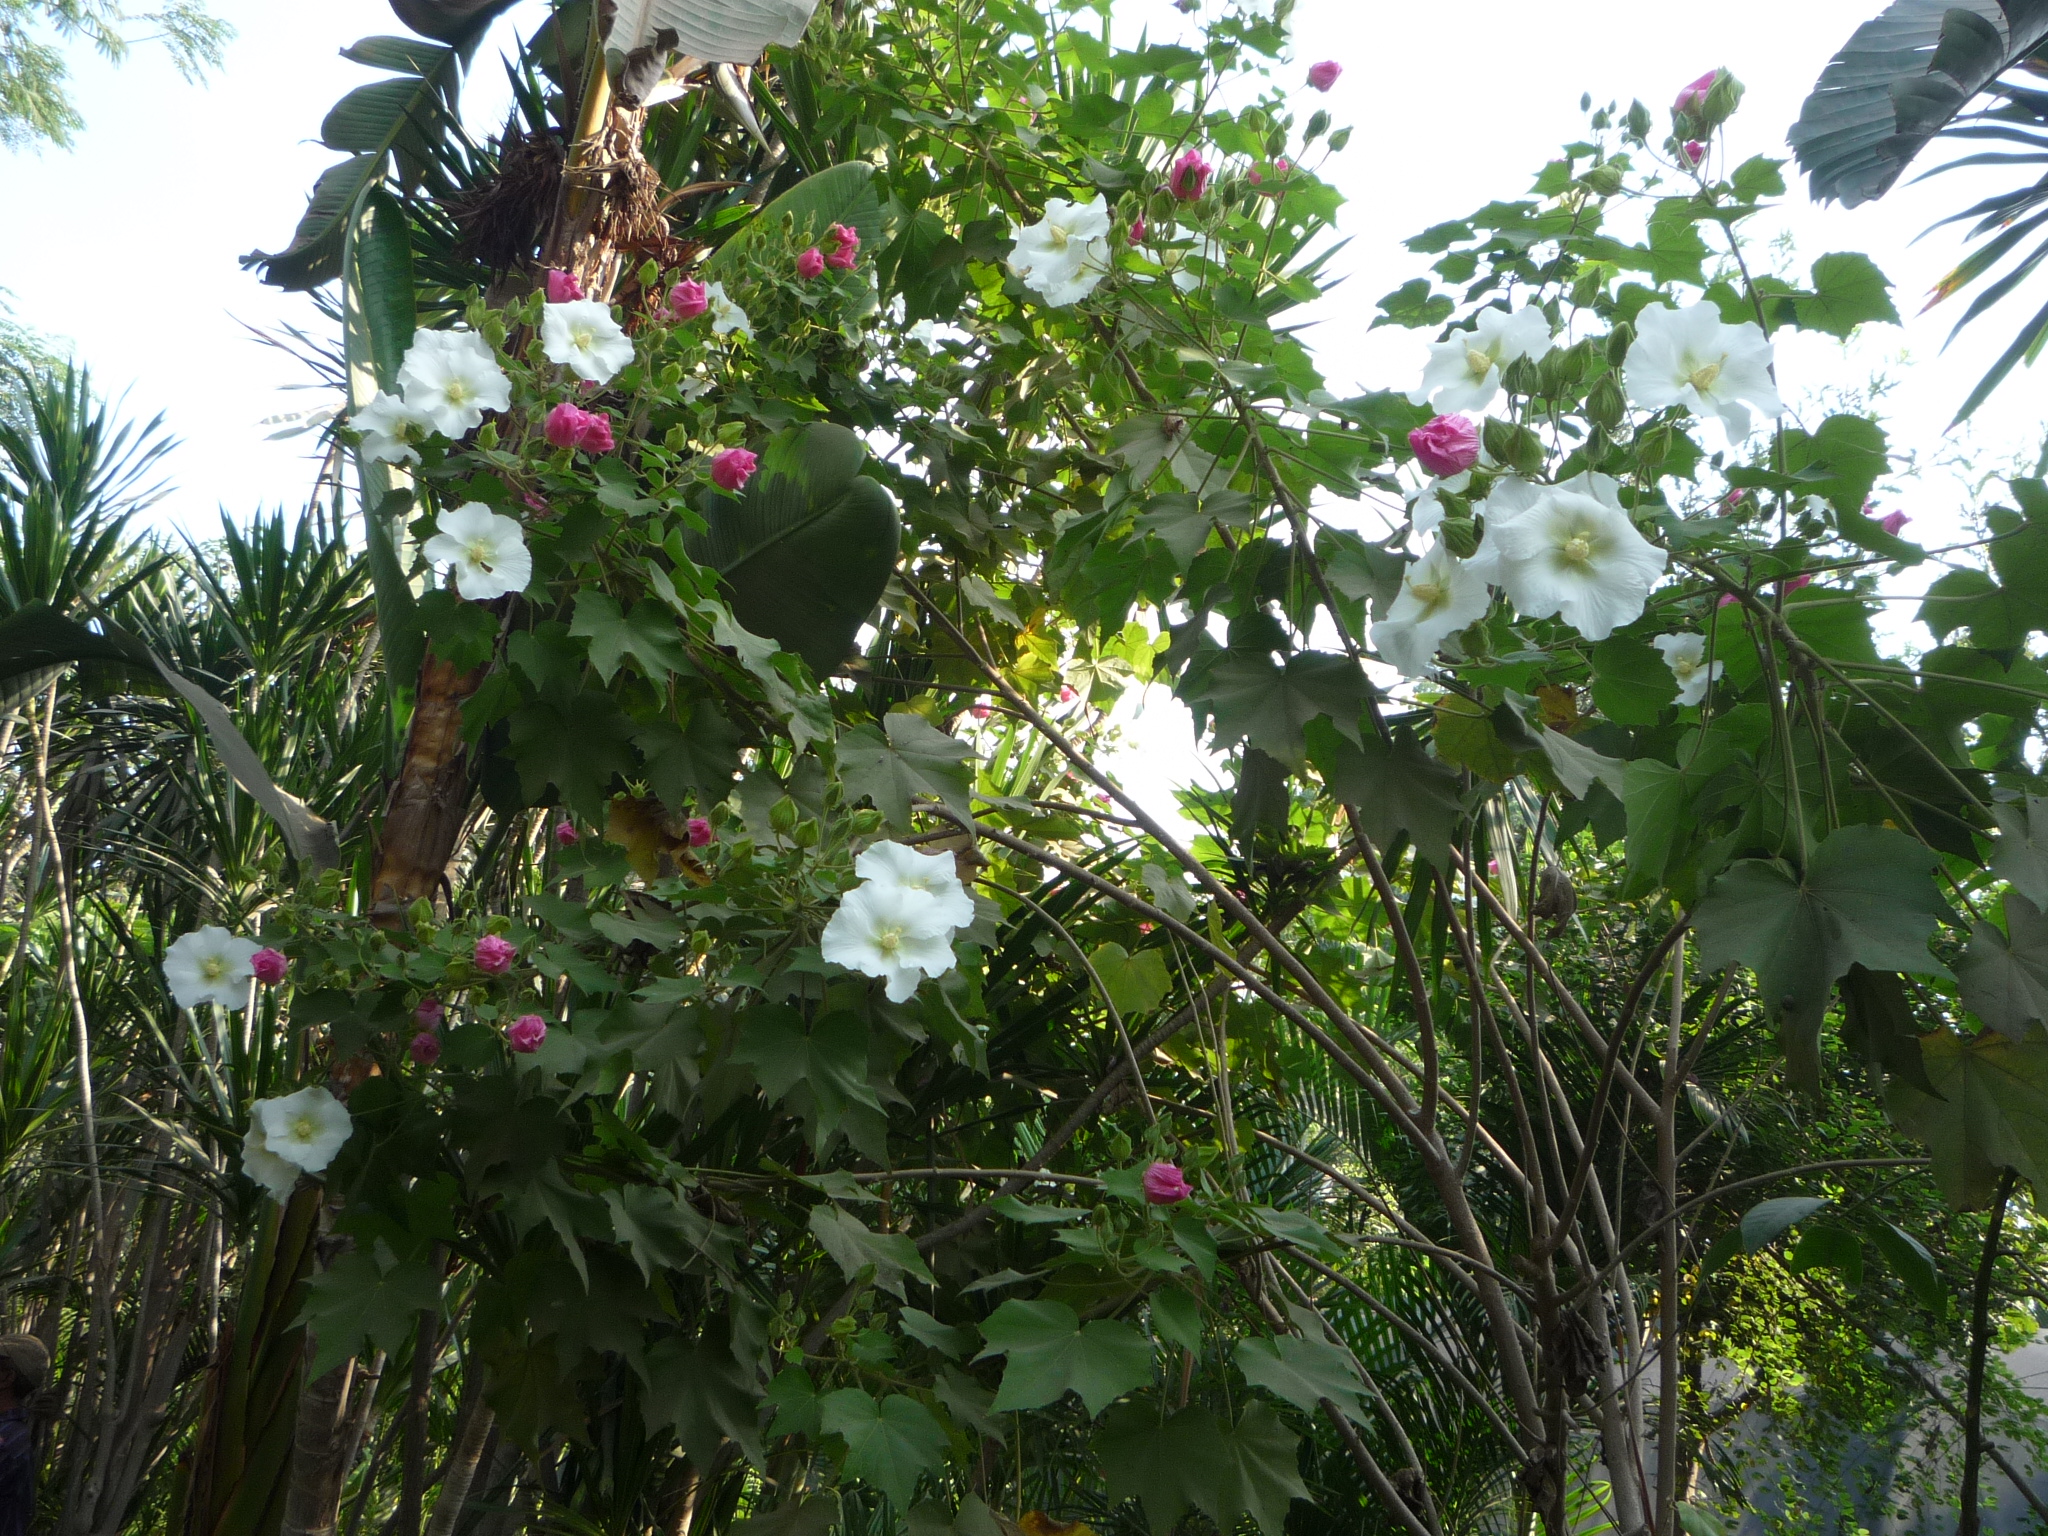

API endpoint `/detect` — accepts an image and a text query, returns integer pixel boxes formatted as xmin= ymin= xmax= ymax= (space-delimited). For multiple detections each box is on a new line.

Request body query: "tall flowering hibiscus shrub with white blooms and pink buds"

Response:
xmin=163 ymin=4 xmax=2048 ymax=1536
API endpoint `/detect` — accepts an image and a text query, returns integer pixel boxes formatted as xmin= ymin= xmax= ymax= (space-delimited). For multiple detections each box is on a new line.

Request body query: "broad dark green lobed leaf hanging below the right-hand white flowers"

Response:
xmin=1694 ymin=827 xmax=1948 ymax=1083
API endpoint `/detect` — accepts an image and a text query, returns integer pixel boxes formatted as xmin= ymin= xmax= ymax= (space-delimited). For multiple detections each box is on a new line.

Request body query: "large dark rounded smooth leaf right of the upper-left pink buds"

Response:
xmin=688 ymin=422 xmax=903 ymax=678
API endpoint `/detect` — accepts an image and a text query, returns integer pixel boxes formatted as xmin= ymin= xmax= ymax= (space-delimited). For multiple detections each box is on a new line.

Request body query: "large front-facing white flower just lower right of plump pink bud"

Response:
xmin=1487 ymin=475 xmax=1665 ymax=641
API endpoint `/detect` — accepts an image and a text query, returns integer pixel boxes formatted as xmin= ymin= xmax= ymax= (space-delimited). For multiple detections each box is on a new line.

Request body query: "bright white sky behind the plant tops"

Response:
xmin=0 ymin=0 xmax=2048 ymax=831
